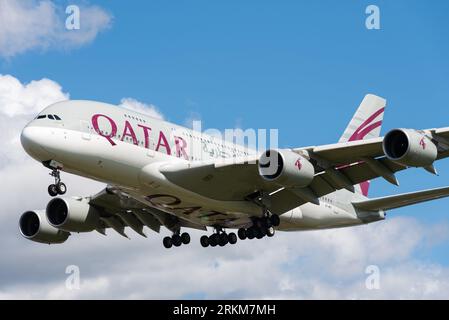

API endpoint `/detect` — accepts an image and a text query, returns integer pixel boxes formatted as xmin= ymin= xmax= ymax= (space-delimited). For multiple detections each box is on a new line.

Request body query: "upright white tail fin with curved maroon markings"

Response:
xmin=339 ymin=94 xmax=387 ymax=196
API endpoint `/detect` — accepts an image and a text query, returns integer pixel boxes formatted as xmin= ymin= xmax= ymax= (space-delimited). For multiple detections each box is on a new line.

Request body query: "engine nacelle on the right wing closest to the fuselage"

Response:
xmin=259 ymin=150 xmax=315 ymax=188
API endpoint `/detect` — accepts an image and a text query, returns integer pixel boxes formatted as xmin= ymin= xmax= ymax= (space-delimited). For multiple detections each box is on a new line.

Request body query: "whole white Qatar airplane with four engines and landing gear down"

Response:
xmin=19 ymin=94 xmax=449 ymax=248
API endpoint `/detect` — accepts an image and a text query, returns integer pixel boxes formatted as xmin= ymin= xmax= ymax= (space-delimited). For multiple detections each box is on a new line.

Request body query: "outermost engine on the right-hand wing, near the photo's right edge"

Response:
xmin=382 ymin=129 xmax=438 ymax=167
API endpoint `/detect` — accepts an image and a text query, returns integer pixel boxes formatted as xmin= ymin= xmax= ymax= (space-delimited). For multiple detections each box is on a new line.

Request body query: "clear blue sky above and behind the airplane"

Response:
xmin=0 ymin=0 xmax=449 ymax=298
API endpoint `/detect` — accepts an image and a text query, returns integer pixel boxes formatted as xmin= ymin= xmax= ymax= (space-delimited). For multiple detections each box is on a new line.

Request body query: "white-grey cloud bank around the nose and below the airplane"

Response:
xmin=0 ymin=76 xmax=449 ymax=299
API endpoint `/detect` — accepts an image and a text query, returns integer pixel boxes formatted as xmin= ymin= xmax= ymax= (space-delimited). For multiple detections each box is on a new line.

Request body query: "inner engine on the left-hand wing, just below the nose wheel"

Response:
xmin=46 ymin=198 xmax=100 ymax=232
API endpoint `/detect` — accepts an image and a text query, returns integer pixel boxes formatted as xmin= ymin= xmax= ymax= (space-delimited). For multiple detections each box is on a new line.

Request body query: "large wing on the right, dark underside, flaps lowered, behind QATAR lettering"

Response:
xmin=160 ymin=128 xmax=449 ymax=214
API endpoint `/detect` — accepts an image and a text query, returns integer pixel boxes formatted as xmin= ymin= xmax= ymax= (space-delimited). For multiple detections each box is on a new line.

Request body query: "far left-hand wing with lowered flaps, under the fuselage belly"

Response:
xmin=89 ymin=186 xmax=206 ymax=237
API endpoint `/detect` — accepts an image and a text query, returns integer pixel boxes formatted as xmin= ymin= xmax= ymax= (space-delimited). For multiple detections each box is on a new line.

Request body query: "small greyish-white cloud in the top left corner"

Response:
xmin=0 ymin=0 xmax=112 ymax=58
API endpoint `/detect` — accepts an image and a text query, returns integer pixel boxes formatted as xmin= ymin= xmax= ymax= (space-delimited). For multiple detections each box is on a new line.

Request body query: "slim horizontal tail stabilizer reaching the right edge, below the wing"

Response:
xmin=352 ymin=187 xmax=449 ymax=211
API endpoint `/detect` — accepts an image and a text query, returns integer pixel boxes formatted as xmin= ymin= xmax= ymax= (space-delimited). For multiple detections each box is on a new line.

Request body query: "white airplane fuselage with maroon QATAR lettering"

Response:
xmin=21 ymin=101 xmax=384 ymax=231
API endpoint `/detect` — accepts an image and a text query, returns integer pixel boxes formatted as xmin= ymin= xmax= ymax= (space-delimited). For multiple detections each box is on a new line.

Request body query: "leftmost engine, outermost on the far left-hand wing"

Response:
xmin=19 ymin=210 xmax=70 ymax=244
